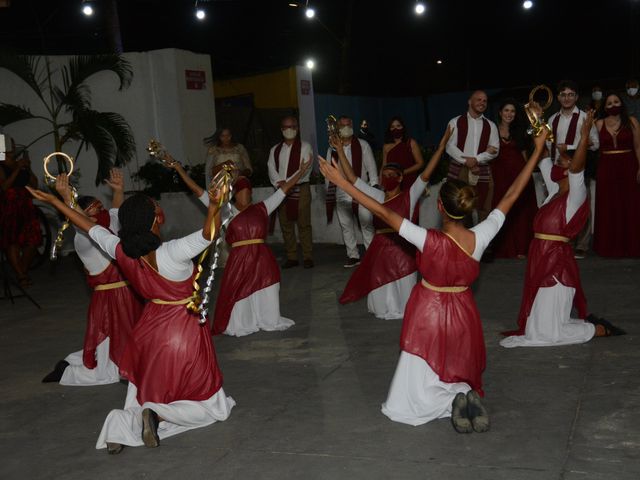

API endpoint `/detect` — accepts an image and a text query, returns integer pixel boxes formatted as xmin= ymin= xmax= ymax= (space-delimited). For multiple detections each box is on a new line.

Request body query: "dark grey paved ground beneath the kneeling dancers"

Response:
xmin=0 ymin=246 xmax=640 ymax=480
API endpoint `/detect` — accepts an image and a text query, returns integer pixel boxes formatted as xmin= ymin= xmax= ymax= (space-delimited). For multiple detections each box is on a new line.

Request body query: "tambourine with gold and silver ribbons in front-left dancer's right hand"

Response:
xmin=187 ymin=164 xmax=238 ymax=325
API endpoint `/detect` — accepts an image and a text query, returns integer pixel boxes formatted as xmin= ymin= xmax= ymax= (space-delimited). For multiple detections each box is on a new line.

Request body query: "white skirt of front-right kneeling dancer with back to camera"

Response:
xmin=382 ymin=352 xmax=471 ymax=426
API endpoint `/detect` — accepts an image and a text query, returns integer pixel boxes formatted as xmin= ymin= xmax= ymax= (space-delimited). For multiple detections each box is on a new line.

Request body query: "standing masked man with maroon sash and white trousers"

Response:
xmin=327 ymin=115 xmax=378 ymax=268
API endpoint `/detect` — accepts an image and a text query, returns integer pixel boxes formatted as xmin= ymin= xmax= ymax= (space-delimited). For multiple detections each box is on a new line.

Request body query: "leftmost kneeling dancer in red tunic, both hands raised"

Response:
xmin=42 ymin=169 xmax=142 ymax=386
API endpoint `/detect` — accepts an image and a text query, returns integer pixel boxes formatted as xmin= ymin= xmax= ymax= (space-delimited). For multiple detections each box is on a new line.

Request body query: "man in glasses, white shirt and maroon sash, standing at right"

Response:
xmin=547 ymin=80 xmax=600 ymax=258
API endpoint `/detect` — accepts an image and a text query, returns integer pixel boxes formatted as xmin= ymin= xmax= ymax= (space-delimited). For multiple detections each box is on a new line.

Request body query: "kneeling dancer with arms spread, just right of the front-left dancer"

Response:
xmin=171 ymin=156 xmax=311 ymax=337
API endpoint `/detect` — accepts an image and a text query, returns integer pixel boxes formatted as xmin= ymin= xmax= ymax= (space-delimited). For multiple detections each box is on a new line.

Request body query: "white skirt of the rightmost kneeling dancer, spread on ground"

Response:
xmin=500 ymin=280 xmax=596 ymax=348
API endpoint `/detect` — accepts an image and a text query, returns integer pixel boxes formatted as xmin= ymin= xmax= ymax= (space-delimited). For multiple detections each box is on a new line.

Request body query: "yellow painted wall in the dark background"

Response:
xmin=213 ymin=67 xmax=298 ymax=108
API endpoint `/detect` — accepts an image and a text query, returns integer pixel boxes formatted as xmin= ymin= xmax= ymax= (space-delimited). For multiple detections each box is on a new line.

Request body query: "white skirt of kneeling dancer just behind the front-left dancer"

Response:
xmin=224 ymin=282 xmax=295 ymax=337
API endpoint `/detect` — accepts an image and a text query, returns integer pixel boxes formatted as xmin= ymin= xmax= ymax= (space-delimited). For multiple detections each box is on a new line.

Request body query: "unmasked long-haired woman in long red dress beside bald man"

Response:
xmin=491 ymin=100 xmax=538 ymax=258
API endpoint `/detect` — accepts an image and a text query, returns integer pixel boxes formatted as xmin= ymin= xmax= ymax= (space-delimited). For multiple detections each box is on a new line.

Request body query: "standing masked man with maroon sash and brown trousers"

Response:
xmin=267 ymin=116 xmax=313 ymax=268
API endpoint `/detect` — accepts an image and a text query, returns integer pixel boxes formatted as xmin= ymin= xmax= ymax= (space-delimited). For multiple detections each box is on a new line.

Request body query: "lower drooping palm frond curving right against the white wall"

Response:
xmin=65 ymin=110 xmax=136 ymax=185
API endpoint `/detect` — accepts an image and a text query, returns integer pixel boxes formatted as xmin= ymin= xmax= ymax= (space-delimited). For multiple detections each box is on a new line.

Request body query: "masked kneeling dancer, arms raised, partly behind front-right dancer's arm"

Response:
xmin=338 ymin=129 xmax=451 ymax=320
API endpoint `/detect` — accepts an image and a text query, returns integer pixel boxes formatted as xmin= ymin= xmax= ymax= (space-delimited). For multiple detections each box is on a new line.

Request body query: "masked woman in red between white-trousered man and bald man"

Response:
xmin=382 ymin=117 xmax=424 ymax=190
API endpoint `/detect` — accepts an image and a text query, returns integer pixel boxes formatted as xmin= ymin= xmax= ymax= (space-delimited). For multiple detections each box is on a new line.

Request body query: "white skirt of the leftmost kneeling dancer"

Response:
xmin=60 ymin=337 xmax=120 ymax=387
